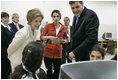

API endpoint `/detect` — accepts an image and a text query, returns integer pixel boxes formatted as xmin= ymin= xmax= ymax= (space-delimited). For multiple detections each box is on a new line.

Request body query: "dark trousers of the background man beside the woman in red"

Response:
xmin=61 ymin=42 xmax=72 ymax=64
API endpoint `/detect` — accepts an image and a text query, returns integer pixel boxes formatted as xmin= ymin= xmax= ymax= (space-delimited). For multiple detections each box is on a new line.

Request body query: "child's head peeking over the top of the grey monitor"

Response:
xmin=89 ymin=45 xmax=105 ymax=60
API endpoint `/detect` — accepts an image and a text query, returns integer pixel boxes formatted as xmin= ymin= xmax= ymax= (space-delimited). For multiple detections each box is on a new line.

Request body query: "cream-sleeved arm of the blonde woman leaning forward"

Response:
xmin=7 ymin=30 xmax=27 ymax=58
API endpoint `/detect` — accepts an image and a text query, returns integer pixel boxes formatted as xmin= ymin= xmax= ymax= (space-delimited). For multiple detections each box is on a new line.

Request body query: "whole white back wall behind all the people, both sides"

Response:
xmin=1 ymin=1 xmax=117 ymax=39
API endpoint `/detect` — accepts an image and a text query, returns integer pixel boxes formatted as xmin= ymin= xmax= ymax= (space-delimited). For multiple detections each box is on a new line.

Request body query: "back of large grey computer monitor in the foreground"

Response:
xmin=60 ymin=60 xmax=117 ymax=79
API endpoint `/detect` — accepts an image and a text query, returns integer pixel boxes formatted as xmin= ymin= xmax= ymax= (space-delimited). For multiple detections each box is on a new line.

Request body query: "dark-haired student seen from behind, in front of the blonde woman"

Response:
xmin=9 ymin=41 xmax=46 ymax=79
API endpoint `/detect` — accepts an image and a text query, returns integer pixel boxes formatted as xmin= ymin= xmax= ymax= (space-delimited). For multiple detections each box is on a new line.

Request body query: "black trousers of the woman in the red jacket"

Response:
xmin=44 ymin=57 xmax=61 ymax=79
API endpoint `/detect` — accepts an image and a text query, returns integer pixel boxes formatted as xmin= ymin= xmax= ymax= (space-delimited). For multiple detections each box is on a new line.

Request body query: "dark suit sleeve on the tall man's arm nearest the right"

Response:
xmin=72 ymin=14 xmax=99 ymax=54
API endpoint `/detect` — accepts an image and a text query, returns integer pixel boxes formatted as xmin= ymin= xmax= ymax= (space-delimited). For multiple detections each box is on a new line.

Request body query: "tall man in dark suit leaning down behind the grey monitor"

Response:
xmin=69 ymin=1 xmax=99 ymax=61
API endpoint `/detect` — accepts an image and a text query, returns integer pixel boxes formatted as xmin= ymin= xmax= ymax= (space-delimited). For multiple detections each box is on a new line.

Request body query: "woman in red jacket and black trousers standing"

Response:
xmin=40 ymin=10 xmax=67 ymax=79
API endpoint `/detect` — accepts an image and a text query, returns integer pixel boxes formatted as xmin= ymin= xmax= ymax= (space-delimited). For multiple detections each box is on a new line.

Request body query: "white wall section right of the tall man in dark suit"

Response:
xmin=85 ymin=1 xmax=117 ymax=40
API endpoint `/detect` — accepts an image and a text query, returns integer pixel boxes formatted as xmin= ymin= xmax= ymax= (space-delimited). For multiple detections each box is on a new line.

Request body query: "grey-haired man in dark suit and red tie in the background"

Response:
xmin=9 ymin=13 xmax=24 ymax=33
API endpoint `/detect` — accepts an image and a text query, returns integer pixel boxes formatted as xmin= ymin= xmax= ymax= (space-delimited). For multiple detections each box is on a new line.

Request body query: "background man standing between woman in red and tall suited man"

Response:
xmin=62 ymin=17 xmax=72 ymax=64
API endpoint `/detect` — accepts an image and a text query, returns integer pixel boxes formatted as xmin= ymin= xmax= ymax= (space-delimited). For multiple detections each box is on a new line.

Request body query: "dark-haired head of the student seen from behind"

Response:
xmin=22 ymin=42 xmax=44 ymax=72
